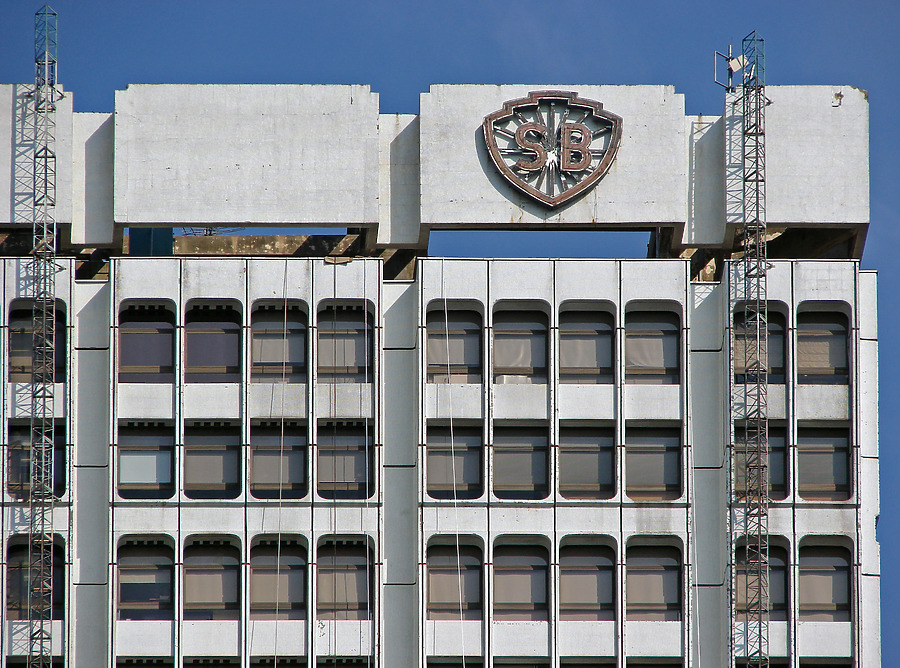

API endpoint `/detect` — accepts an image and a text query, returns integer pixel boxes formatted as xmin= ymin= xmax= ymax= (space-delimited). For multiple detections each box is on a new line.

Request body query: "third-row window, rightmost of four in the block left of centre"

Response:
xmin=316 ymin=542 xmax=375 ymax=619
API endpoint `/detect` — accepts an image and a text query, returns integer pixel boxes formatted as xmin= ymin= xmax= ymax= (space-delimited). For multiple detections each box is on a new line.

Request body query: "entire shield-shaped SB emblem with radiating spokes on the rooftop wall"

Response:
xmin=484 ymin=90 xmax=622 ymax=207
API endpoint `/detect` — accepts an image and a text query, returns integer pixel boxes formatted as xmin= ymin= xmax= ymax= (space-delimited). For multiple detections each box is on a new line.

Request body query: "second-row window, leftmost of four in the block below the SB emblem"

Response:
xmin=425 ymin=427 xmax=484 ymax=499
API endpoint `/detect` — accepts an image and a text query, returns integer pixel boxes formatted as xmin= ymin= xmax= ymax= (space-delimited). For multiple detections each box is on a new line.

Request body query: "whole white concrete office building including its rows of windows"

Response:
xmin=0 ymin=85 xmax=880 ymax=668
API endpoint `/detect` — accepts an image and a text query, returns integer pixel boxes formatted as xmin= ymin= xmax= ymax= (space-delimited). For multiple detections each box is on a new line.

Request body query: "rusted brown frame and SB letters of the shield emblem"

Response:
xmin=483 ymin=90 xmax=622 ymax=208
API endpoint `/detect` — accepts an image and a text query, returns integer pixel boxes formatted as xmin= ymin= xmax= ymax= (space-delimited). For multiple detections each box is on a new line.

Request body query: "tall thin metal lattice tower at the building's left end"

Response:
xmin=28 ymin=5 xmax=60 ymax=668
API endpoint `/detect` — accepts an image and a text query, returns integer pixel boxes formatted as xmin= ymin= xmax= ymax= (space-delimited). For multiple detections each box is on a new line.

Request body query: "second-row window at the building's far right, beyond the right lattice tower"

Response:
xmin=797 ymin=426 xmax=850 ymax=501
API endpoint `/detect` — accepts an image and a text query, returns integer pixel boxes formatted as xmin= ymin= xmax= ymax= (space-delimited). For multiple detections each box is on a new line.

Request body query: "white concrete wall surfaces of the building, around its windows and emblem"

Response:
xmin=0 ymin=85 xmax=881 ymax=668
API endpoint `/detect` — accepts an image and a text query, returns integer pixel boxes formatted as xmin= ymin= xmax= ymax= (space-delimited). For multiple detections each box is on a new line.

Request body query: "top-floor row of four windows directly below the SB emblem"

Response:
xmin=426 ymin=309 xmax=681 ymax=384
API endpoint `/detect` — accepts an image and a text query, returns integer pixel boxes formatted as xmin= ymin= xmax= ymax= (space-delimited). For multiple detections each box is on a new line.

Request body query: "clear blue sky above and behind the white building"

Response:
xmin=0 ymin=0 xmax=900 ymax=668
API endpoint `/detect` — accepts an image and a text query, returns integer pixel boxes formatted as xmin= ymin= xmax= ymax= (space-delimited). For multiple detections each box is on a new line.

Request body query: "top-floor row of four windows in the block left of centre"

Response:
xmin=115 ymin=300 xmax=375 ymax=383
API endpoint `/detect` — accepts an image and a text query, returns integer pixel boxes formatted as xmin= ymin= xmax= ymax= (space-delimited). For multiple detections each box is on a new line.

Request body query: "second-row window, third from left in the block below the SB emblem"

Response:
xmin=559 ymin=427 xmax=616 ymax=499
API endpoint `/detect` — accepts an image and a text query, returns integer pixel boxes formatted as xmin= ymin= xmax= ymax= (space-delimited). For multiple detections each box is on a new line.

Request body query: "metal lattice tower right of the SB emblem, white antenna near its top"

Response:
xmin=732 ymin=31 xmax=769 ymax=668
